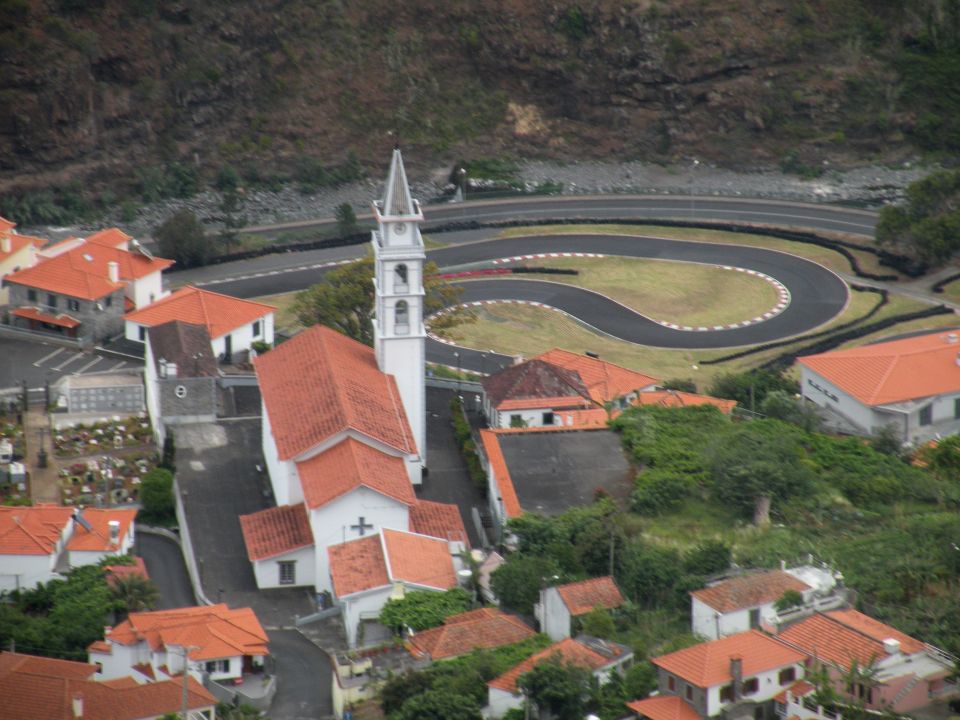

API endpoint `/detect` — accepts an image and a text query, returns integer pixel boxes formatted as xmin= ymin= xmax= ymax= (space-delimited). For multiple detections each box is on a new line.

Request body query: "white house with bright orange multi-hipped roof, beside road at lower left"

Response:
xmin=87 ymin=604 xmax=269 ymax=682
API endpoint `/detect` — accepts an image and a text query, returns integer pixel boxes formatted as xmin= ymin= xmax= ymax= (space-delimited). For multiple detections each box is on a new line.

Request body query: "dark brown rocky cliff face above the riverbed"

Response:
xmin=0 ymin=0 xmax=928 ymax=192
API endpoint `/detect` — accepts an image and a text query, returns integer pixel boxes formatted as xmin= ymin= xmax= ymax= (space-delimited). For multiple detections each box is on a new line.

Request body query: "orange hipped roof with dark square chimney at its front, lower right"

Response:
xmin=651 ymin=630 xmax=805 ymax=688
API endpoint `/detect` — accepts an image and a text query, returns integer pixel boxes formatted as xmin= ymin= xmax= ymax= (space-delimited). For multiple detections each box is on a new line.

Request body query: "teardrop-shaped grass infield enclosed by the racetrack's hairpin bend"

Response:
xmin=506 ymin=256 xmax=779 ymax=326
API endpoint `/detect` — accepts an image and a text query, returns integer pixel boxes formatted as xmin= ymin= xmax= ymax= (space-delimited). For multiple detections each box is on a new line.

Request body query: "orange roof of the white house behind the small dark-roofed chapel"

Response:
xmin=123 ymin=285 xmax=276 ymax=339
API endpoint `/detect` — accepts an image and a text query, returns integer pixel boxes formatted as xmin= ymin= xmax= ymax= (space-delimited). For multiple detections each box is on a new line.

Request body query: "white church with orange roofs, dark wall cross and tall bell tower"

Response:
xmin=240 ymin=149 xmax=467 ymax=638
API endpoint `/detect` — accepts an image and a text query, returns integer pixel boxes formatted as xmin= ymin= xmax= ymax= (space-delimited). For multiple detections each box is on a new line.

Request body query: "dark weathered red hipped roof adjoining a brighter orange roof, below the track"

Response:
xmin=482 ymin=358 xmax=592 ymax=409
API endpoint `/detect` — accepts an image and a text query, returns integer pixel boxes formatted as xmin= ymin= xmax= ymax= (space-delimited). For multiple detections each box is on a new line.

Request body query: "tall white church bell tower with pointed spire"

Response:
xmin=372 ymin=148 xmax=427 ymax=470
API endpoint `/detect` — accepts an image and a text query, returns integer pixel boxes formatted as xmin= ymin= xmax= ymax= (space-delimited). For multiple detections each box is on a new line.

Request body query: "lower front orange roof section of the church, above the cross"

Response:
xmin=297 ymin=437 xmax=417 ymax=508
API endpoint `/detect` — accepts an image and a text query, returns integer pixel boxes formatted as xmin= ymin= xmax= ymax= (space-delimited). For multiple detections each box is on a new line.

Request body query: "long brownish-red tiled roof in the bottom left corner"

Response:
xmin=0 ymin=652 xmax=217 ymax=720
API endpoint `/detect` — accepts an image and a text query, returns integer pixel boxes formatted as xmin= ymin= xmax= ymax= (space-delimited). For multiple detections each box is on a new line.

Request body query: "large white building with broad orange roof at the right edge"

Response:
xmin=797 ymin=331 xmax=960 ymax=445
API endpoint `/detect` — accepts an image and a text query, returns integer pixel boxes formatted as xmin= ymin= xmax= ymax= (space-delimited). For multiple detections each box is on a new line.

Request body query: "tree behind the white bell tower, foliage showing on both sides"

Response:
xmin=293 ymin=257 xmax=475 ymax=345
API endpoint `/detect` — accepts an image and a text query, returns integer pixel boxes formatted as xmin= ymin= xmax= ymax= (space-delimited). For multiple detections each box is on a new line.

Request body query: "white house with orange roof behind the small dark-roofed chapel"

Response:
xmin=123 ymin=285 xmax=276 ymax=359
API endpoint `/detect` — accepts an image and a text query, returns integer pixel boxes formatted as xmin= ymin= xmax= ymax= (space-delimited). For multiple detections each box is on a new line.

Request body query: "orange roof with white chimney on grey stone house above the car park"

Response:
xmin=6 ymin=235 xmax=173 ymax=300
